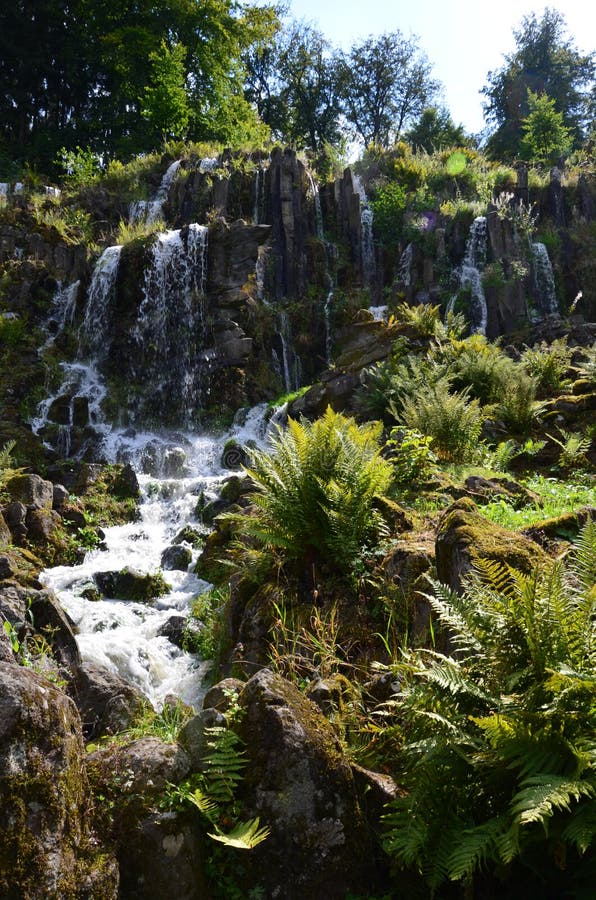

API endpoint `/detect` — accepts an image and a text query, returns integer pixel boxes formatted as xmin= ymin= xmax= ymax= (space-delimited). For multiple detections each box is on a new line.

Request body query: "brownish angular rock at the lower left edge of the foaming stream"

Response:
xmin=68 ymin=662 xmax=147 ymax=740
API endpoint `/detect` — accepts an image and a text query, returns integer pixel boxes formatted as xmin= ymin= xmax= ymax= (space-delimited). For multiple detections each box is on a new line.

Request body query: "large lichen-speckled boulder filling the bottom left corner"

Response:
xmin=0 ymin=662 xmax=118 ymax=900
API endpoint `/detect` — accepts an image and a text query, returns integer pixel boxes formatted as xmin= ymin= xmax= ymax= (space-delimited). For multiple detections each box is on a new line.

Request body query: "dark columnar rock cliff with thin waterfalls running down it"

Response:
xmin=0 ymin=148 xmax=596 ymax=455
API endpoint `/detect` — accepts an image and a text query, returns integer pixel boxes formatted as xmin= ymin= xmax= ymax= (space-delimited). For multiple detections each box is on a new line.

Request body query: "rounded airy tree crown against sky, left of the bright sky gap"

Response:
xmin=338 ymin=31 xmax=439 ymax=147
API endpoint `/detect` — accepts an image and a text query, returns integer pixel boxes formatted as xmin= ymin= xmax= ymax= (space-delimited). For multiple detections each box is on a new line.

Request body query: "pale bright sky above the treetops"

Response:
xmin=289 ymin=0 xmax=596 ymax=133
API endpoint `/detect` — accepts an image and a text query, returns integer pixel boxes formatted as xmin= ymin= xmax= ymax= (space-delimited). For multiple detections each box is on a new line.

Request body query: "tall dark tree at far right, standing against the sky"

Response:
xmin=482 ymin=8 xmax=594 ymax=159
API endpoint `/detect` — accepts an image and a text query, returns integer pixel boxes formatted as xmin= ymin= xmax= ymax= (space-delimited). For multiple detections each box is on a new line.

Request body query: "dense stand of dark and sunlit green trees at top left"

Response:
xmin=0 ymin=0 xmax=278 ymax=167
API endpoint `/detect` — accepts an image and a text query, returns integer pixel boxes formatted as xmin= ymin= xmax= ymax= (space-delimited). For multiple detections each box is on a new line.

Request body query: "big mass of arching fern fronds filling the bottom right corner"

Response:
xmin=385 ymin=523 xmax=596 ymax=896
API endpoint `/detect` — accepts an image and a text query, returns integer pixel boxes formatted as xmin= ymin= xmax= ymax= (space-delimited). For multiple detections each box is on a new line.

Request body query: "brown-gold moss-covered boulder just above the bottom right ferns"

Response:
xmin=435 ymin=498 xmax=548 ymax=591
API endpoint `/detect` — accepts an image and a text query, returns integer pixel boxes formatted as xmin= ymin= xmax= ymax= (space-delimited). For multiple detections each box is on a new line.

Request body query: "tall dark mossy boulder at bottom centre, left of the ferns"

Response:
xmin=240 ymin=669 xmax=377 ymax=900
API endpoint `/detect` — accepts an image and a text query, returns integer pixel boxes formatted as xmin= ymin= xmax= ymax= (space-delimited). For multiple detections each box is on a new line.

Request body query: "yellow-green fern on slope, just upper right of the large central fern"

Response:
xmin=400 ymin=378 xmax=483 ymax=462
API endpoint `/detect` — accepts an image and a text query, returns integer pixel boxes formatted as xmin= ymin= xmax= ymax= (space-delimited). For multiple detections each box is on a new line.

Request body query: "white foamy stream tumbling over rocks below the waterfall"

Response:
xmin=41 ymin=404 xmax=278 ymax=708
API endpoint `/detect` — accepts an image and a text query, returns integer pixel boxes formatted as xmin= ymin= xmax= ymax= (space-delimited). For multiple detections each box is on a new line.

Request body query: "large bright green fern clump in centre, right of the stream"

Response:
xmin=235 ymin=407 xmax=392 ymax=571
